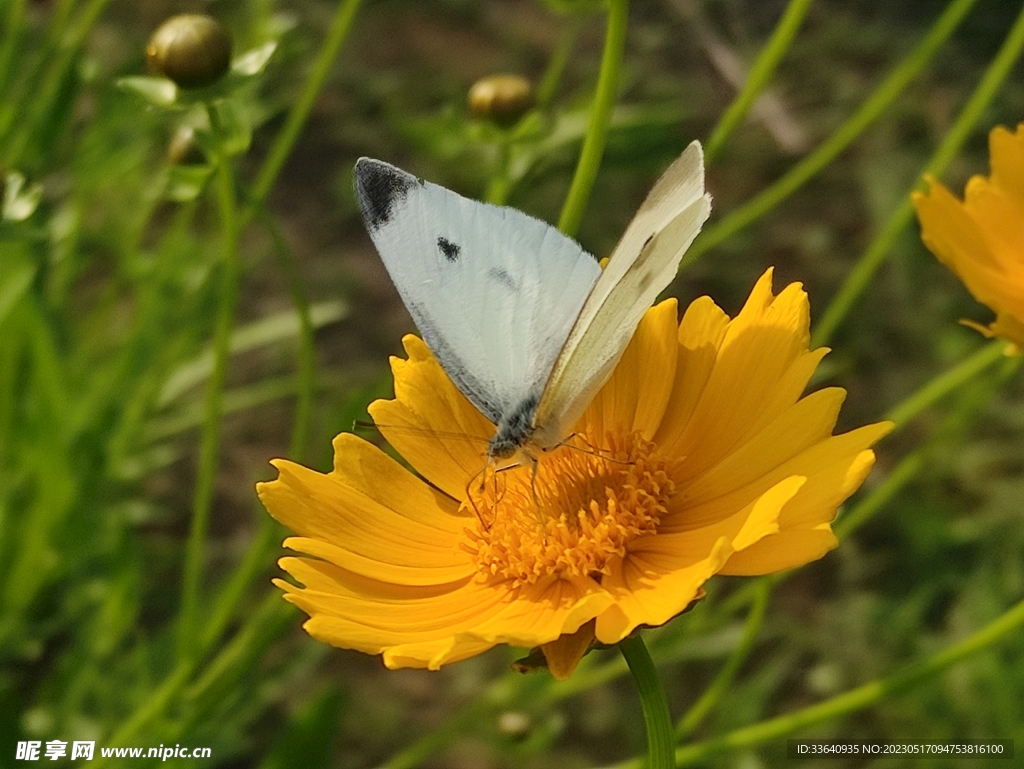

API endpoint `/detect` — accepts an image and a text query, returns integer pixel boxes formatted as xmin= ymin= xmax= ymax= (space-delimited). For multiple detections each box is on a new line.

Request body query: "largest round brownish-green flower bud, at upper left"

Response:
xmin=145 ymin=13 xmax=231 ymax=88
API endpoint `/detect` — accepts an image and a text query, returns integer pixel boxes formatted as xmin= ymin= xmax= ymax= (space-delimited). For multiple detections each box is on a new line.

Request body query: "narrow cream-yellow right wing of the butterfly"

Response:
xmin=532 ymin=141 xmax=711 ymax=447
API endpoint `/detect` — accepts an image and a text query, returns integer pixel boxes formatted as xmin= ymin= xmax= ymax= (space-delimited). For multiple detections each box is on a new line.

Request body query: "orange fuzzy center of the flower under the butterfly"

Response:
xmin=463 ymin=432 xmax=675 ymax=586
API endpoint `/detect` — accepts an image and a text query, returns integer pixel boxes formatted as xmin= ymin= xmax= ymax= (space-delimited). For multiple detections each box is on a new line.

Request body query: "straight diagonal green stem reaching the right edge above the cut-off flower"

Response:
xmin=812 ymin=0 xmax=1024 ymax=347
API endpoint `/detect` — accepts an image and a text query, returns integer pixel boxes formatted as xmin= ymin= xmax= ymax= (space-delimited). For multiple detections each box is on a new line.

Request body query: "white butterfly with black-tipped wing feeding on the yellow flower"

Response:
xmin=355 ymin=141 xmax=711 ymax=462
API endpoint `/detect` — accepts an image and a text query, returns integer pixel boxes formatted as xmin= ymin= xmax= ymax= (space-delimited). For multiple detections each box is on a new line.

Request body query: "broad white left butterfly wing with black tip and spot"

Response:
xmin=355 ymin=158 xmax=601 ymax=424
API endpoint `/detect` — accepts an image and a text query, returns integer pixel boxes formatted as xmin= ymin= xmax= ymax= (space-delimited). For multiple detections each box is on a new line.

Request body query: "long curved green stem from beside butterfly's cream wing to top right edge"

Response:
xmin=683 ymin=0 xmax=977 ymax=266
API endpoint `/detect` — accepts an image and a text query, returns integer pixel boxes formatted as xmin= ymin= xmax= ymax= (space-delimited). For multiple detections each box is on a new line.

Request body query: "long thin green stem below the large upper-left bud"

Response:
xmin=178 ymin=135 xmax=242 ymax=659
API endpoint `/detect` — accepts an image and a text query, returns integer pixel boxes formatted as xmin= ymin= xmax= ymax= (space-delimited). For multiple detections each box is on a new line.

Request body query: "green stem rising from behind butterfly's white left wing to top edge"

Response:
xmin=558 ymin=0 xmax=630 ymax=237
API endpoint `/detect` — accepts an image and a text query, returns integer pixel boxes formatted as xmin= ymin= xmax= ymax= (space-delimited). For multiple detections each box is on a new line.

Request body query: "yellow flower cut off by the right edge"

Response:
xmin=912 ymin=123 xmax=1024 ymax=352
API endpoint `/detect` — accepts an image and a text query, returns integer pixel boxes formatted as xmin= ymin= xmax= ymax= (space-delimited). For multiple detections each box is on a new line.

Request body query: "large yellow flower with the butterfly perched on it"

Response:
xmin=258 ymin=270 xmax=891 ymax=677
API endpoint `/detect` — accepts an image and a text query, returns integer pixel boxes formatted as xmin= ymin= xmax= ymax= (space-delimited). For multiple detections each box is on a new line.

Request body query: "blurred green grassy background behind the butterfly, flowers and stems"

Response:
xmin=0 ymin=0 xmax=1024 ymax=769
